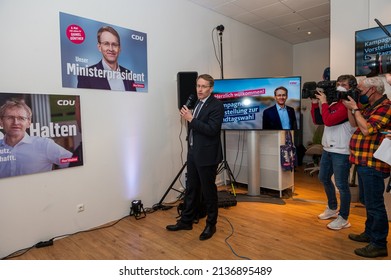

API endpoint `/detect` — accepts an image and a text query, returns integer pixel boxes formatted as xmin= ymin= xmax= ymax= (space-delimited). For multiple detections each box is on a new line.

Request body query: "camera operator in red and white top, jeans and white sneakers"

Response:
xmin=311 ymin=75 xmax=357 ymax=230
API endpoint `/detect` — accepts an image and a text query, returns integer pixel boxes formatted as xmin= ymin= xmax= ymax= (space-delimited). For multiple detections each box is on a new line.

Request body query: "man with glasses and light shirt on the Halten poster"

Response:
xmin=0 ymin=100 xmax=72 ymax=178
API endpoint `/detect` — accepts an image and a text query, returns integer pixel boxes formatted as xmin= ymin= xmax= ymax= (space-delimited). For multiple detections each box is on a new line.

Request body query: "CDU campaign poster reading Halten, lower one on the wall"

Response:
xmin=0 ymin=92 xmax=83 ymax=179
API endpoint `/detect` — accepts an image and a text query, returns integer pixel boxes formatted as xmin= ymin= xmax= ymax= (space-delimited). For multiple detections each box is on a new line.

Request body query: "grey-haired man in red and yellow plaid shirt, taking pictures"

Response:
xmin=343 ymin=77 xmax=391 ymax=258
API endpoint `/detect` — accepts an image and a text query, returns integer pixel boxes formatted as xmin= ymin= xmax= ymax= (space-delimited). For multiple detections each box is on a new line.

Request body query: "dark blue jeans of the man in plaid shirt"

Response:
xmin=357 ymin=166 xmax=389 ymax=248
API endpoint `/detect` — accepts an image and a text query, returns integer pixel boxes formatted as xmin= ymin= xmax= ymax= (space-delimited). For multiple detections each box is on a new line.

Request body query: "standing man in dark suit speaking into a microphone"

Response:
xmin=166 ymin=74 xmax=224 ymax=240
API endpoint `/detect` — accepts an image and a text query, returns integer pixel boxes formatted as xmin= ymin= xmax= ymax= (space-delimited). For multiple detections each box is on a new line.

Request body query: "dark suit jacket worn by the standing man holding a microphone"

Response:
xmin=189 ymin=95 xmax=224 ymax=166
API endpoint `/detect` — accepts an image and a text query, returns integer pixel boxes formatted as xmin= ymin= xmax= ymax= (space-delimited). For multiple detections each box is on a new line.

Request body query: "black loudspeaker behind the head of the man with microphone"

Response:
xmin=177 ymin=72 xmax=198 ymax=109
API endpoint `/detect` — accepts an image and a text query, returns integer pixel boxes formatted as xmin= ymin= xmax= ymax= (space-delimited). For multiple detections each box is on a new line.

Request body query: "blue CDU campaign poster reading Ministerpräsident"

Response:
xmin=60 ymin=12 xmax=148 ymax=92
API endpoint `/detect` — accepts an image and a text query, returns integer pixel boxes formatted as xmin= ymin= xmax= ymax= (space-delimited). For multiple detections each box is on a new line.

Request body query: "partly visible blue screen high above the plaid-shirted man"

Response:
xmin=355 ymin=24 xmax=391 ymax=77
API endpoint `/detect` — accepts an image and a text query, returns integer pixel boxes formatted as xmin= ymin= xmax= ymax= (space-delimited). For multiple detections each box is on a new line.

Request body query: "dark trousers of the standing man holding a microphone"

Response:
xmin=181 ymin=149 xmax=218 ymax=226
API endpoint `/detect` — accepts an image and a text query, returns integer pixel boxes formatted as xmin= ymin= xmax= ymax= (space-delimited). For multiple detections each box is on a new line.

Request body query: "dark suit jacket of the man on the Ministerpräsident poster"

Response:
xmin=77 ymin=60 xmax=136 ymax=91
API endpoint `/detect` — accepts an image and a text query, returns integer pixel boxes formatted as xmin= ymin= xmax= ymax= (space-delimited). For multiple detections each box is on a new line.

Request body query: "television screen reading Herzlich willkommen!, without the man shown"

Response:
xmin=213 ymin=76 xmax=301 ymax=130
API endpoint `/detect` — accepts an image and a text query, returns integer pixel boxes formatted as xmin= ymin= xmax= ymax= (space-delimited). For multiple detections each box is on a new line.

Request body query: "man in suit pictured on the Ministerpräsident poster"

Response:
xmin=77 ymin=26 xmax=136 ymax=91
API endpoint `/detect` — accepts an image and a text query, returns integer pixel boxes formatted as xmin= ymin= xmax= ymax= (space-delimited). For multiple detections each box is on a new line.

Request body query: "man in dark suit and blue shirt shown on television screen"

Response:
xmin=262 ymin=86 xmax=297 ymax=130
